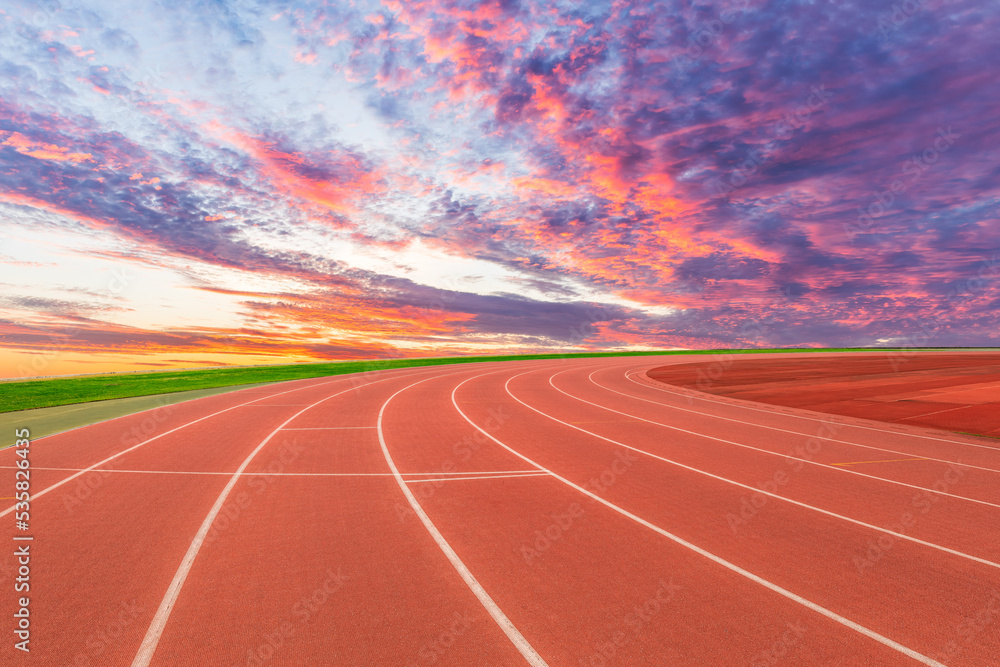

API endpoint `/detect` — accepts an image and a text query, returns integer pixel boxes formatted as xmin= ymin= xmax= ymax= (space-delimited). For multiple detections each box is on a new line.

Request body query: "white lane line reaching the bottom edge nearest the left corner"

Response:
xmin=132 ymin=370 xmax=434 ymax=667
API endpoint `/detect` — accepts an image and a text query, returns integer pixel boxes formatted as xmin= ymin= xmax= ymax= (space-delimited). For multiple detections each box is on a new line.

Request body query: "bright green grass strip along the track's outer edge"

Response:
xmin=0 ymin=348 xmax=968 ymax=413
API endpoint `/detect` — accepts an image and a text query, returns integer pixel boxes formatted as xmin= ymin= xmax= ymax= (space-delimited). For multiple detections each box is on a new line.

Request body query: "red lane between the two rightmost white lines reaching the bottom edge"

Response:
xmin=376 ymin=366 xmax=911 ymax=665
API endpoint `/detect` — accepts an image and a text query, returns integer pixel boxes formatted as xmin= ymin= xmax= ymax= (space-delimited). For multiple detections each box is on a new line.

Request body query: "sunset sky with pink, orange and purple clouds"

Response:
xmin=0 ymin=0 xmax=1000 ymax=377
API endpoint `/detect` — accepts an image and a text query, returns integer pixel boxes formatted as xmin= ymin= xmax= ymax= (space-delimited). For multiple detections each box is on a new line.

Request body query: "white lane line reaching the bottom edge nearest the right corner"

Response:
xmin=451 ymin=374 xmax=946 ymax=667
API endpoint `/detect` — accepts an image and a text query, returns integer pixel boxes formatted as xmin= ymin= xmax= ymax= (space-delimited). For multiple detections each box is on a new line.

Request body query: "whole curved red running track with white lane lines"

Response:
xmin=0 ymin=354 xmax=1000 ymax=667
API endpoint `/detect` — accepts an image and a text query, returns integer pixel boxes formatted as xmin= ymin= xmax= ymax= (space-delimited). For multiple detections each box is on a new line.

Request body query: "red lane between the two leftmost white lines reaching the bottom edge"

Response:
xmin=133 ymin=368 xmax=544 ymax=665
